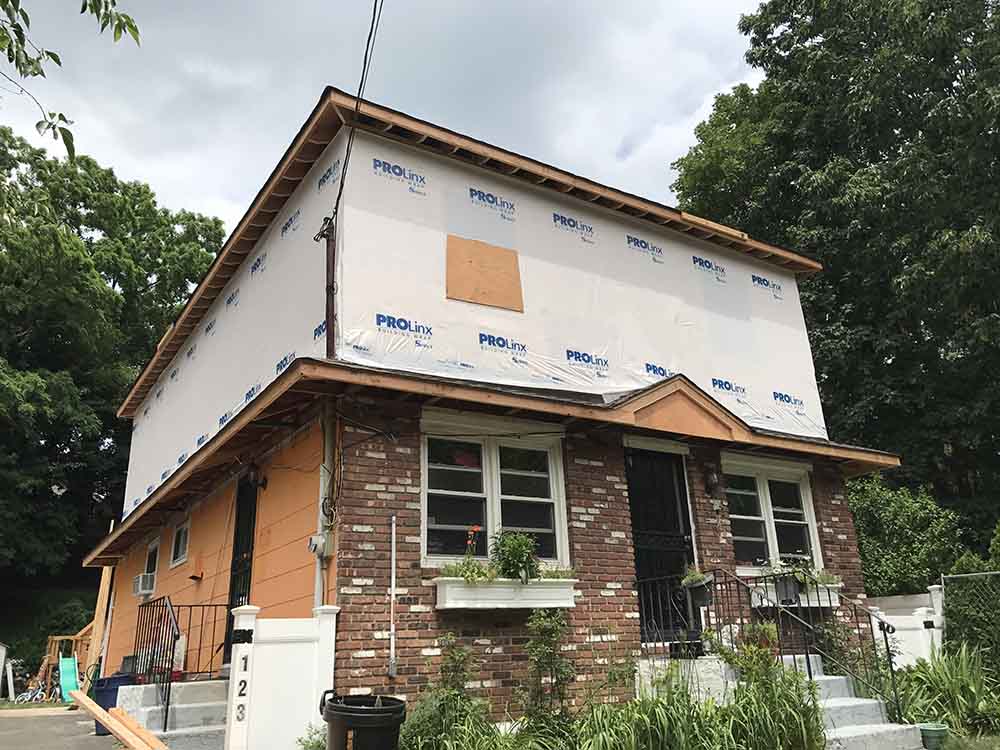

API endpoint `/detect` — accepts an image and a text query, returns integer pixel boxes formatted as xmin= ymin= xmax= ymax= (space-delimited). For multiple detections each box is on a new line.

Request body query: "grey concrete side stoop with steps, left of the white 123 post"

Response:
xmin=118 ymin=680 xmax=229 ymax=737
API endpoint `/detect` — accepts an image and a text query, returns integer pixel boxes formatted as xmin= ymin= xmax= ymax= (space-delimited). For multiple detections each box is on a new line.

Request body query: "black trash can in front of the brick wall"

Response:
xmin=319 ymin=690 xmax=406 ymax=750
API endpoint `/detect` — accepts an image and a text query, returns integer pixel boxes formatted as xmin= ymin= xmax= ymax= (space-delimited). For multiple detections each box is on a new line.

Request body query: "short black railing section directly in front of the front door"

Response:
xmin=636 ymin=576 xmax=708 ymax=658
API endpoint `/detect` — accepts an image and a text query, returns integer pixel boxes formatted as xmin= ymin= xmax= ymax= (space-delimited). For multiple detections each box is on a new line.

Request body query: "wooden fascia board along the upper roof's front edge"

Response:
xmin=330 ymin=89 xmax=823 ymax=272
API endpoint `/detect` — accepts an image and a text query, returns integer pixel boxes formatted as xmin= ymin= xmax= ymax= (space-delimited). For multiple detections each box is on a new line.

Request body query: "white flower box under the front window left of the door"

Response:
xmin=433 ymin=577 xmax=577 ymax=609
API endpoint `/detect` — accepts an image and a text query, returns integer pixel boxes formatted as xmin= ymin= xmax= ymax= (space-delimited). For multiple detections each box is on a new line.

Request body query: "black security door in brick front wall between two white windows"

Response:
xmin=625 ymin=449 xmax=700 ymax=643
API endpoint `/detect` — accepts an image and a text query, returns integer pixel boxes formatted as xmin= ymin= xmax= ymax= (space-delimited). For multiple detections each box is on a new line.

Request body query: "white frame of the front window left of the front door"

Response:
xmin=420 ymin=409 xmax=570 ymax=568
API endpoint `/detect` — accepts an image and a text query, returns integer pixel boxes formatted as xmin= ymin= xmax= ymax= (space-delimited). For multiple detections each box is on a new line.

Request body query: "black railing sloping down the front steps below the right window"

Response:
xmin=709 ymin=570 xmax=903 ymax=721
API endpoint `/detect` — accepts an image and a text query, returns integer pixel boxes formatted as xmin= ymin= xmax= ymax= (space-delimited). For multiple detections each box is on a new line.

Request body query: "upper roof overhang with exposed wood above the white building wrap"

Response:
xmin=118 ymin=87 xmax=822 ymax=424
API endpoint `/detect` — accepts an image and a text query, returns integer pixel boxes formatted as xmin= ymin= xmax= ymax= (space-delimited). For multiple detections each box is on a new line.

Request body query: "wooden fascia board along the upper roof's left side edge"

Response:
xmin=117 ymin=97 xmax=336 ymax=418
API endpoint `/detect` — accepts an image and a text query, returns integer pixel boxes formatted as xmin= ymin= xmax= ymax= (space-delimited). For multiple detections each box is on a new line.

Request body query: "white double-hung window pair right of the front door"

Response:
xmin=722 ymin=454 xmax=822 ymax=568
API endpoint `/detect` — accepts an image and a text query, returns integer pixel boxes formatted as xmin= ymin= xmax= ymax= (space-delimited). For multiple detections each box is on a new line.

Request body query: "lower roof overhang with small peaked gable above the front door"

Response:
xmin=83 ymin=359 xmax=900 ymax=566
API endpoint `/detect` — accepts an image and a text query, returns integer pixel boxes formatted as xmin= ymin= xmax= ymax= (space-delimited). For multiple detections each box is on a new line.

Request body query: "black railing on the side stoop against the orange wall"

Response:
xmin=133 ymin=596 xmax=228 ymax=732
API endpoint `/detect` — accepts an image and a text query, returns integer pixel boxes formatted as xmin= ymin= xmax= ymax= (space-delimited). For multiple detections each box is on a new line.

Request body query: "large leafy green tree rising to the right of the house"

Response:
xmin=674 ymin=0 xmax=1000 ymax=551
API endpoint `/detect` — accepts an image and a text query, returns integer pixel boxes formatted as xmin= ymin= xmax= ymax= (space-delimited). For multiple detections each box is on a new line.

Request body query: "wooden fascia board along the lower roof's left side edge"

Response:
xmin=83 ymin=363 xmax=302 ymax=568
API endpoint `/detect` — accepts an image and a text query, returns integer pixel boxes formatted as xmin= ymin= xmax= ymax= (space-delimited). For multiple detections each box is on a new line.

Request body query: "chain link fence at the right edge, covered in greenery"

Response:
xmin=941 ymin=570 xmax=1000 ymax=674
